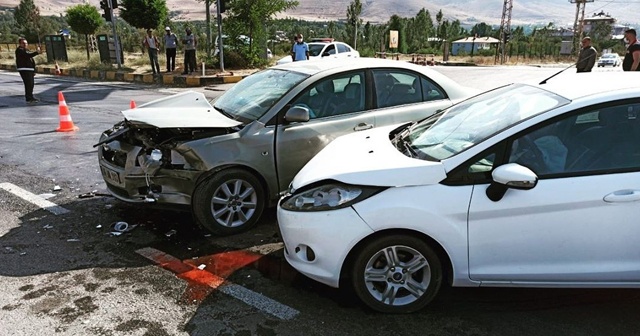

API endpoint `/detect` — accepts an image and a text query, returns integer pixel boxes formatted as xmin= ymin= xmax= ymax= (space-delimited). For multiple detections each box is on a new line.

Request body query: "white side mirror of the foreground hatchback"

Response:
xmin=487 ymin=163 xmax=538 ymax=202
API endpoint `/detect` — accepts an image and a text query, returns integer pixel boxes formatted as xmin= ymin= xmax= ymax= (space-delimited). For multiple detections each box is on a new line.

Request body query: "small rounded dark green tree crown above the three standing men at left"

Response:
xmin=119 ymin=0 xmax=169 ymax=29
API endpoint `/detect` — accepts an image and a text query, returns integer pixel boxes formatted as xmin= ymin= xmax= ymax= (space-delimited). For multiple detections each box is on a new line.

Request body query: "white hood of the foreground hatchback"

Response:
xmin=292 ymin=125 xmax=447 ymax=189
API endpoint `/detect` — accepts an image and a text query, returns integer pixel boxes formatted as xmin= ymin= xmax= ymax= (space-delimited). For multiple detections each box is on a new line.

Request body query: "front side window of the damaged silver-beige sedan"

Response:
xmin=291 ymin=71 xmax=365 ymax=119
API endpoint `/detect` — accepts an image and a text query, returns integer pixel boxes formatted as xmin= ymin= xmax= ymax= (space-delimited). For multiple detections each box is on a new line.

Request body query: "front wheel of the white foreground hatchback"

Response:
xmin=351 ymin=235 xmax=442 ymax=314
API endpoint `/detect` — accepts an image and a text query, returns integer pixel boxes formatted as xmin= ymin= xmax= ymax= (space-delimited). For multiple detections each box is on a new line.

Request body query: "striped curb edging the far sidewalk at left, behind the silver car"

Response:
xmin=0 ymin=64 xmax=247 ymax=87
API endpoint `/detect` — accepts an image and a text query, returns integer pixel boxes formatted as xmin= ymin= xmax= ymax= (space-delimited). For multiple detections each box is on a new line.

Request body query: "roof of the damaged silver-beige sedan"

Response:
xmin=272 ymin=57 xmax=436 ymax=76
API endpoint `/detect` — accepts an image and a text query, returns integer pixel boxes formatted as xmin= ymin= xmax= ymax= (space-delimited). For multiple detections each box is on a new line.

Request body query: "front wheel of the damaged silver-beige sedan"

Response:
xmin=193 ymin=169 xmax=265 ymax=236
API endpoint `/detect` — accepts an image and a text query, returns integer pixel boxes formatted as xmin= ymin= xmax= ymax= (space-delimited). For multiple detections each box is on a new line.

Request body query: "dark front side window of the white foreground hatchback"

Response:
xmin=509 ymin=103 xmax=640 ymax=177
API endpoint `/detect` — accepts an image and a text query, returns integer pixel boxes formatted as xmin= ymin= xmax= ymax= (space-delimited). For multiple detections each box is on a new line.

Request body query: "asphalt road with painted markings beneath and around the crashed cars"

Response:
xmin=0 ymin=67 xmax=640 ymax=336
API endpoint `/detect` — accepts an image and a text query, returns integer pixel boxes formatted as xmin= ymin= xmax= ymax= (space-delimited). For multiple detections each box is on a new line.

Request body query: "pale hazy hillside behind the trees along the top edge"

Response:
xmin=0 ymin=0 xmax=640 ymax=25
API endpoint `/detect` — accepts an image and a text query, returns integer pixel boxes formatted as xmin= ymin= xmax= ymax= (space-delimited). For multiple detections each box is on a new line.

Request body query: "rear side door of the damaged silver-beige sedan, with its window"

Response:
xmin=372 ymin=68 xmax=451 ymax=126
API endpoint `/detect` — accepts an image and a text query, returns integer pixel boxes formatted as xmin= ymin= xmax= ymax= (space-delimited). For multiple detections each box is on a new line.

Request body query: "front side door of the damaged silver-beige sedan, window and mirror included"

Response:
xmin=275 ymin=71 xmax=375 ymax=190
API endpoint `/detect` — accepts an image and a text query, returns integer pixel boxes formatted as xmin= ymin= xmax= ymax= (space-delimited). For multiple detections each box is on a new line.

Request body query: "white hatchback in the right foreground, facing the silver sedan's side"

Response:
xmin=278 ymin=72 xmax=640 ymax=313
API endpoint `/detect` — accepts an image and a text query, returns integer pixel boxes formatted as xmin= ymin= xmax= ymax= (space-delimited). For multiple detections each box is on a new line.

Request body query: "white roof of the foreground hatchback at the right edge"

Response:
xmin=535 ymin=69 xmax=640 ymax=100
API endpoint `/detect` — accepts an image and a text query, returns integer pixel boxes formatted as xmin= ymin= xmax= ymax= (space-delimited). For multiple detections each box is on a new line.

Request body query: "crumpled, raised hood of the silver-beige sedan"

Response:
xmin=122 ymin=91 xmax=242 ymax=128
